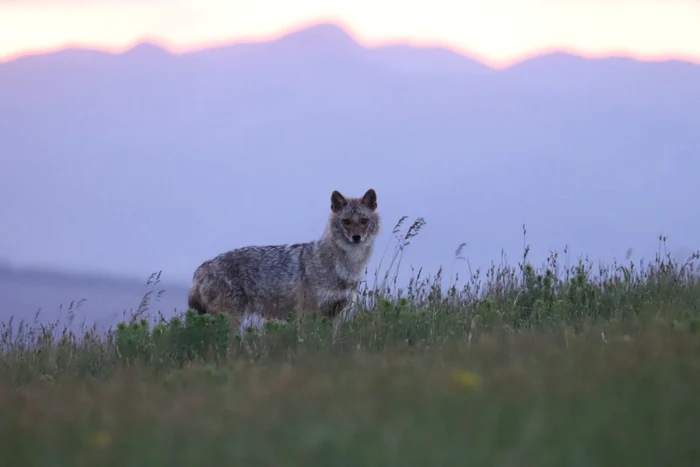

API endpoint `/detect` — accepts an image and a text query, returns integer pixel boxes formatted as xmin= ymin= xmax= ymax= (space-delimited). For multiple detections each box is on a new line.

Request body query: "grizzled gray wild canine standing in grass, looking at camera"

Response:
xmin=189 ymin=189 xmax=380 ymax=325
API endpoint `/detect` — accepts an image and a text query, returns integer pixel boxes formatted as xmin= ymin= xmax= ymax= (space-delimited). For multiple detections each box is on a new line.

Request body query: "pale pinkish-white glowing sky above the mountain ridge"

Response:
xmin=0 ymin=0 xmax=700 ymax=66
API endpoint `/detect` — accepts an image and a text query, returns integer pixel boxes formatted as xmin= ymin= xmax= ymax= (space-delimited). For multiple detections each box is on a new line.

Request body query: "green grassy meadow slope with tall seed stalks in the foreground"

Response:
xmin=0 ymin=219 xmax=700 ymax=467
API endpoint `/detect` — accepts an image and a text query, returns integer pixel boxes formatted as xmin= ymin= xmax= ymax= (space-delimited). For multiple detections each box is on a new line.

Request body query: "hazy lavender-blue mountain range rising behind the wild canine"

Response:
xmin=0 ymin=24 xmax=700 ymax=330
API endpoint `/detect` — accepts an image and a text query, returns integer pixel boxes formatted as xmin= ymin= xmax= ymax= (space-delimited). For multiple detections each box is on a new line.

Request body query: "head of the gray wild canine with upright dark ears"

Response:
xmin=329 ymin=188 xmax=379 ymax=245
